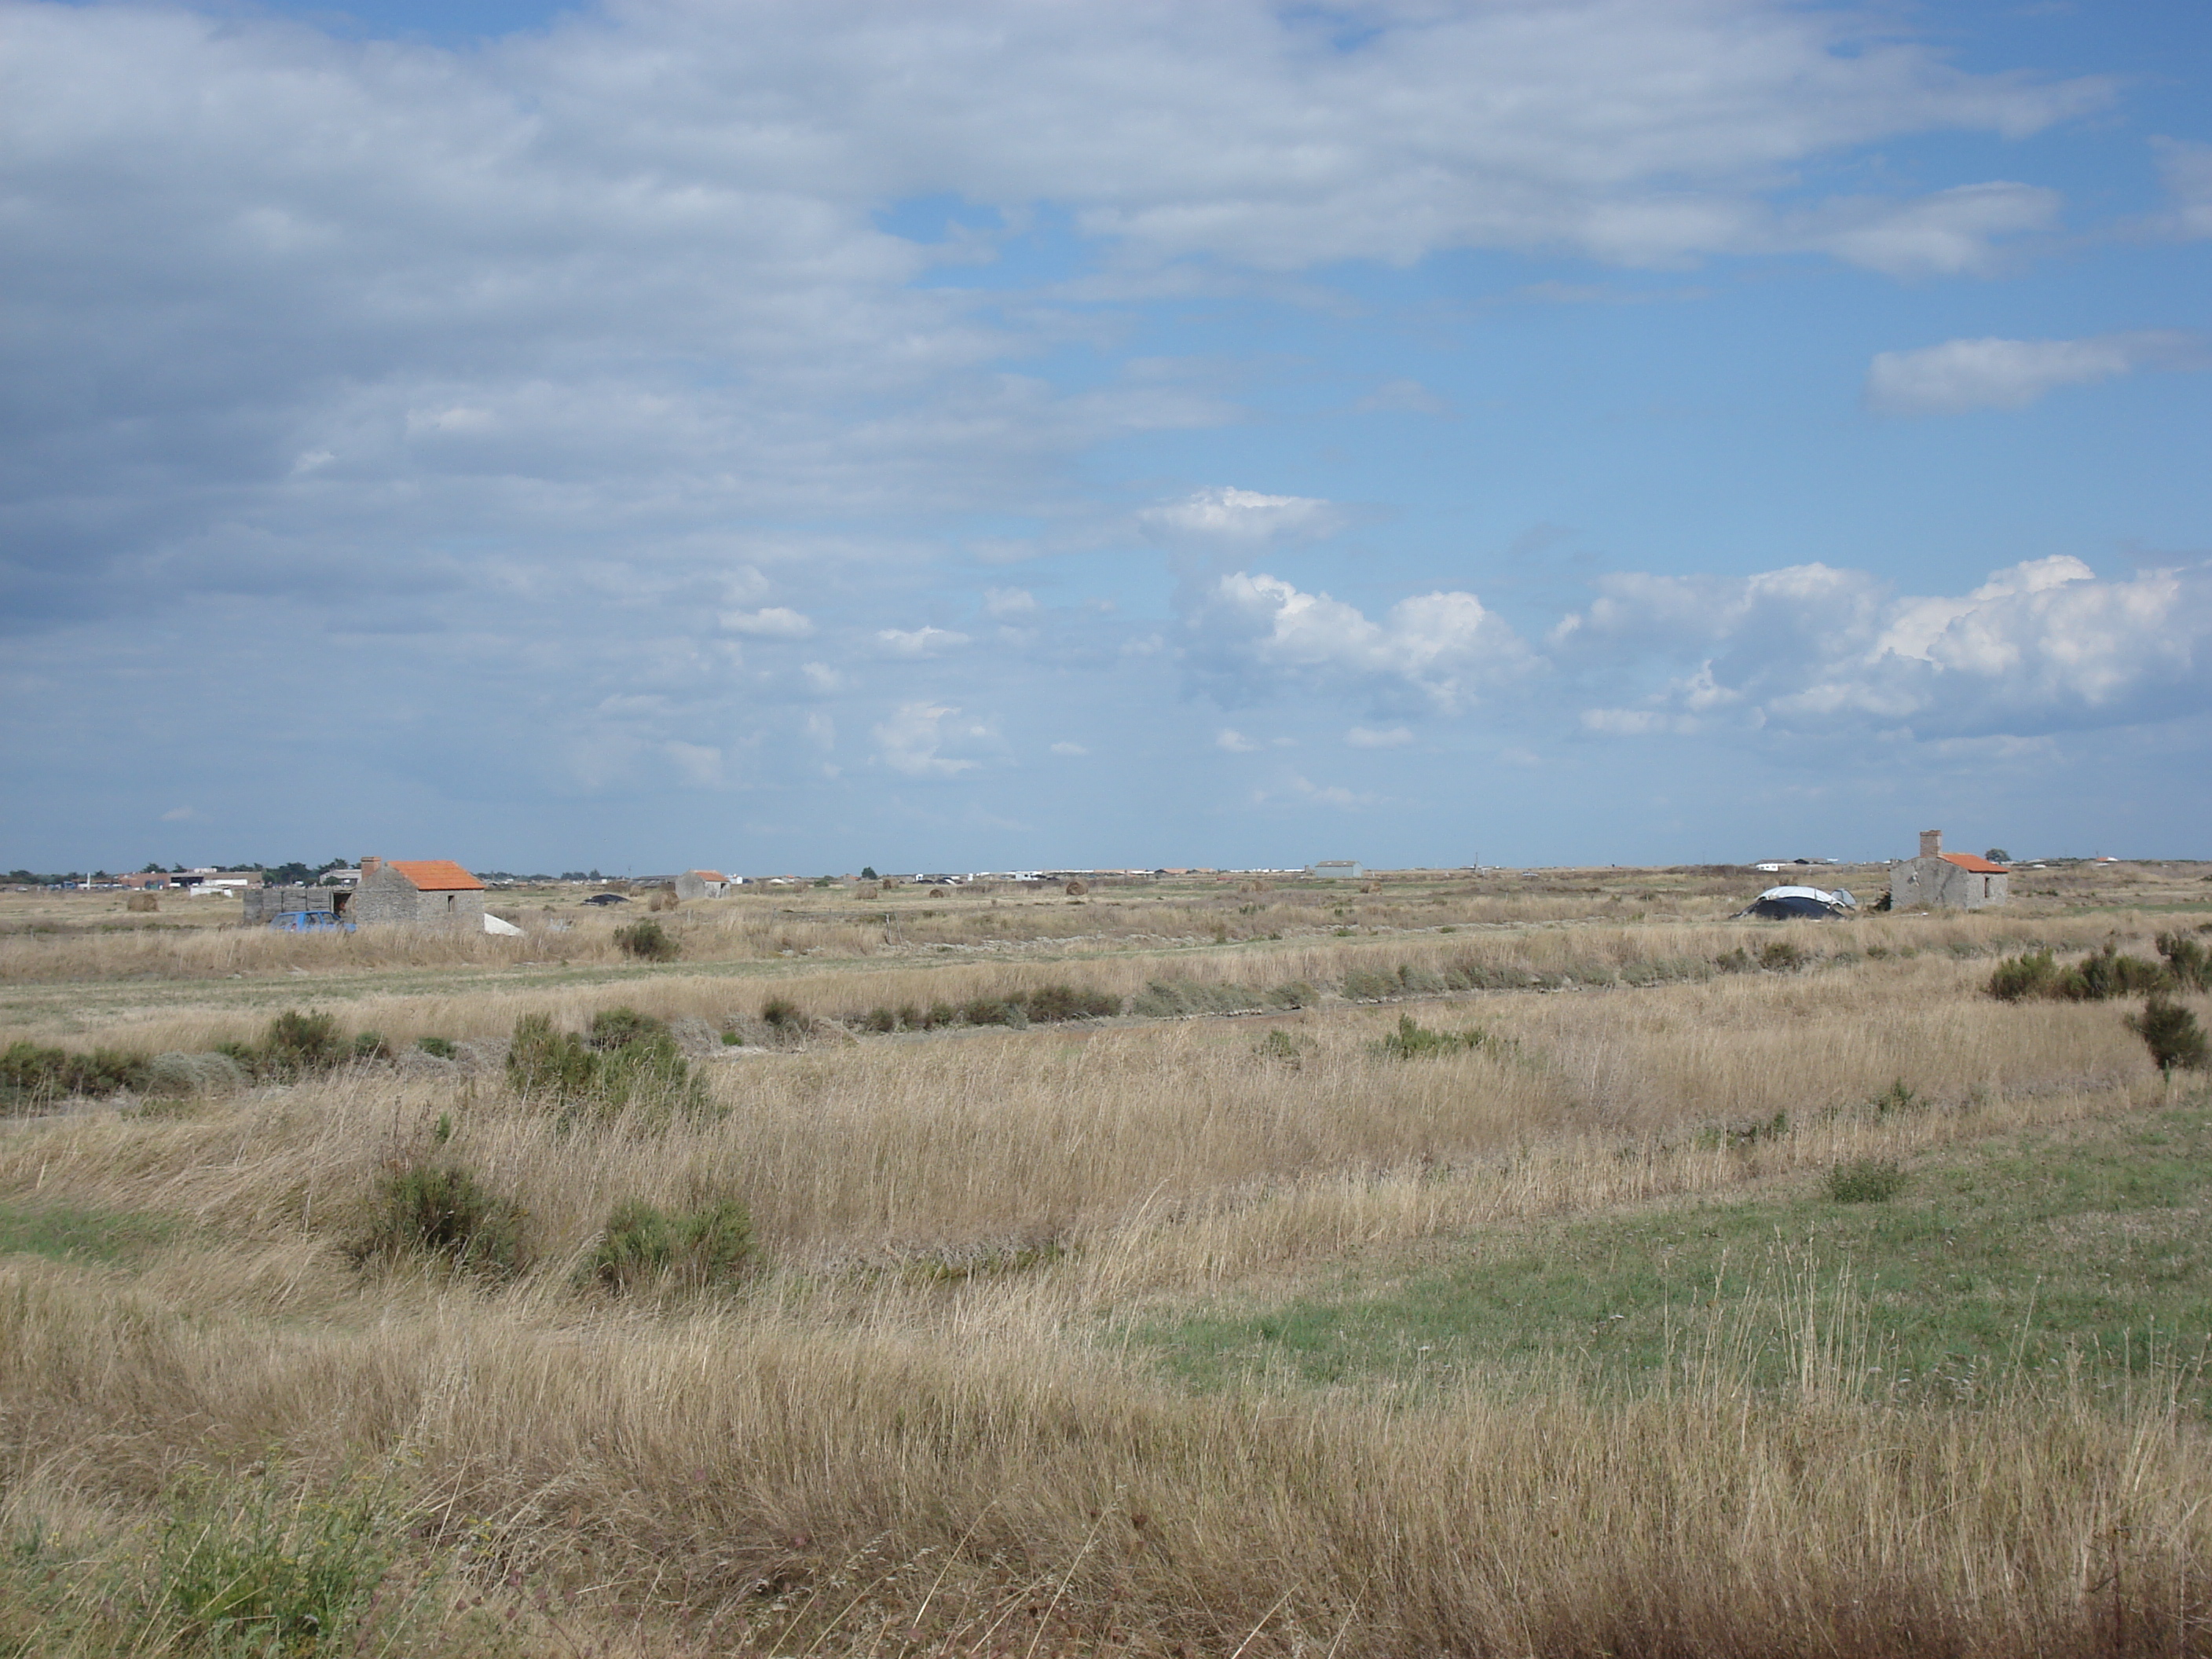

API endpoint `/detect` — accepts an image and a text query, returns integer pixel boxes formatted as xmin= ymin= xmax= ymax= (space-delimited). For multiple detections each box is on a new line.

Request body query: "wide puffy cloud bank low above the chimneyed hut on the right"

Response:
xmin=1553 ymin=558 xmax=2212 ymax=737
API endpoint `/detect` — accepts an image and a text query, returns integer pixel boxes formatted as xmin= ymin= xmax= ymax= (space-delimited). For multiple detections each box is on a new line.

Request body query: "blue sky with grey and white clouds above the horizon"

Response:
xmin=0 ymin=0 xmax=2212 ymax=873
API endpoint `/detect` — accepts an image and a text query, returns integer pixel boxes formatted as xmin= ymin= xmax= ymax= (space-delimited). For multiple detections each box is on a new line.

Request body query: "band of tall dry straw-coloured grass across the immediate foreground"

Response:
xmin=0 ymin=1269 xmax=2212 ymax=1654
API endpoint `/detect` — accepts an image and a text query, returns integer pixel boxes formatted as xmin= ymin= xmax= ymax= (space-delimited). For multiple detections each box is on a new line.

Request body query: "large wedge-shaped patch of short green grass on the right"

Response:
xmin=1137 ymin=1095 xmax=2212 ymax=1404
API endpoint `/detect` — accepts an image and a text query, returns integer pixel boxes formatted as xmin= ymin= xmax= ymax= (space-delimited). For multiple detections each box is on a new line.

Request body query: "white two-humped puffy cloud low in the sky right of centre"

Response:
xmin=1185 ymin=571 xmax=1535 ymax=712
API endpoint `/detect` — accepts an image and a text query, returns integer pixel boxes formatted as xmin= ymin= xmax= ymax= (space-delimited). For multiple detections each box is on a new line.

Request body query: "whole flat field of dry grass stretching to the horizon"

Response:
xmin=0 ymin=865 xmax=2212 ymax=1654
